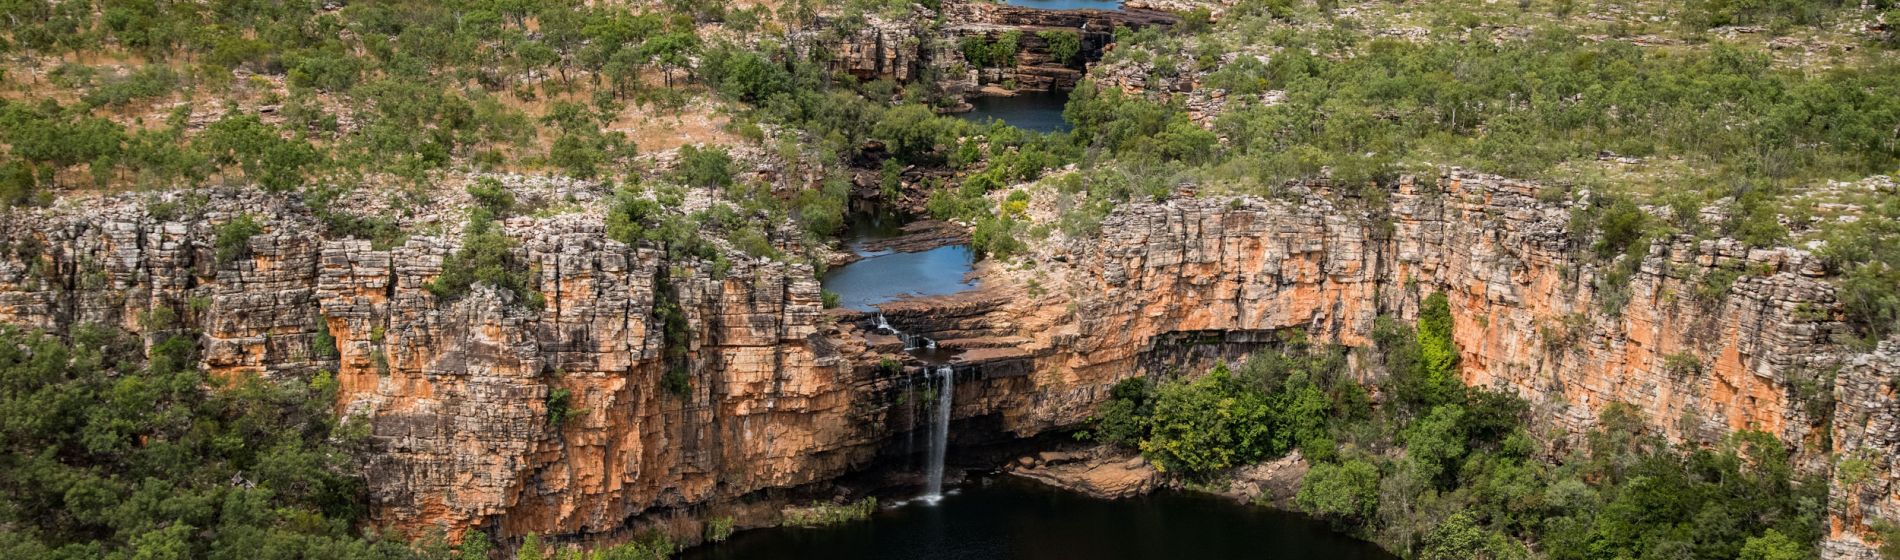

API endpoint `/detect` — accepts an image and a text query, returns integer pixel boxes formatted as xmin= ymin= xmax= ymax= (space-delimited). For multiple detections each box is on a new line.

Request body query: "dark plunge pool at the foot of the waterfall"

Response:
xmin=684 ymin=476 xmax=1395 ymax=560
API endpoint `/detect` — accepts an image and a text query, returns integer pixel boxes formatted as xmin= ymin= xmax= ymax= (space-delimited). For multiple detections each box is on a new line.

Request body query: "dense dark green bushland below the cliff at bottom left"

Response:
xmin=0 ymin=327 xmax=675 ymax=560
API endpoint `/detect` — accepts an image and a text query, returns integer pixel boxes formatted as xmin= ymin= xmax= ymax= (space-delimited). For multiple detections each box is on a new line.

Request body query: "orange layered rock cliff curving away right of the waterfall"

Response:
xmin=887 ymin=171 xmax=1900 ymax=558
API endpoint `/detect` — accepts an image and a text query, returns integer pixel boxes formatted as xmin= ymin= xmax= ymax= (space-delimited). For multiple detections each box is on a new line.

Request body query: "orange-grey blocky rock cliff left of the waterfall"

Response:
xmin=0 ymin=192 xmax=915 ymax=535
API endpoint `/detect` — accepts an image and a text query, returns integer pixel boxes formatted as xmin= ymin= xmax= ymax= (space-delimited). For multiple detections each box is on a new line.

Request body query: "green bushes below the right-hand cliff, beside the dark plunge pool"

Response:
xmin=1091 ymin=294 xmax=1828 ymax=558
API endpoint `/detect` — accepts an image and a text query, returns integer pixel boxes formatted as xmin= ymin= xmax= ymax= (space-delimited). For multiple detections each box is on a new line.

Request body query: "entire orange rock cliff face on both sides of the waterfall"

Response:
xmin=0 ymin=173 xmax=1900 ymax=558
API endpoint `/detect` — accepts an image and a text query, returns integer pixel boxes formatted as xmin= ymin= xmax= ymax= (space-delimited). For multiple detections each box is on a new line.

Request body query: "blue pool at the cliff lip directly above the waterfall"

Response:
xmin=821 ymin=215 xmax=977 ymax=311
